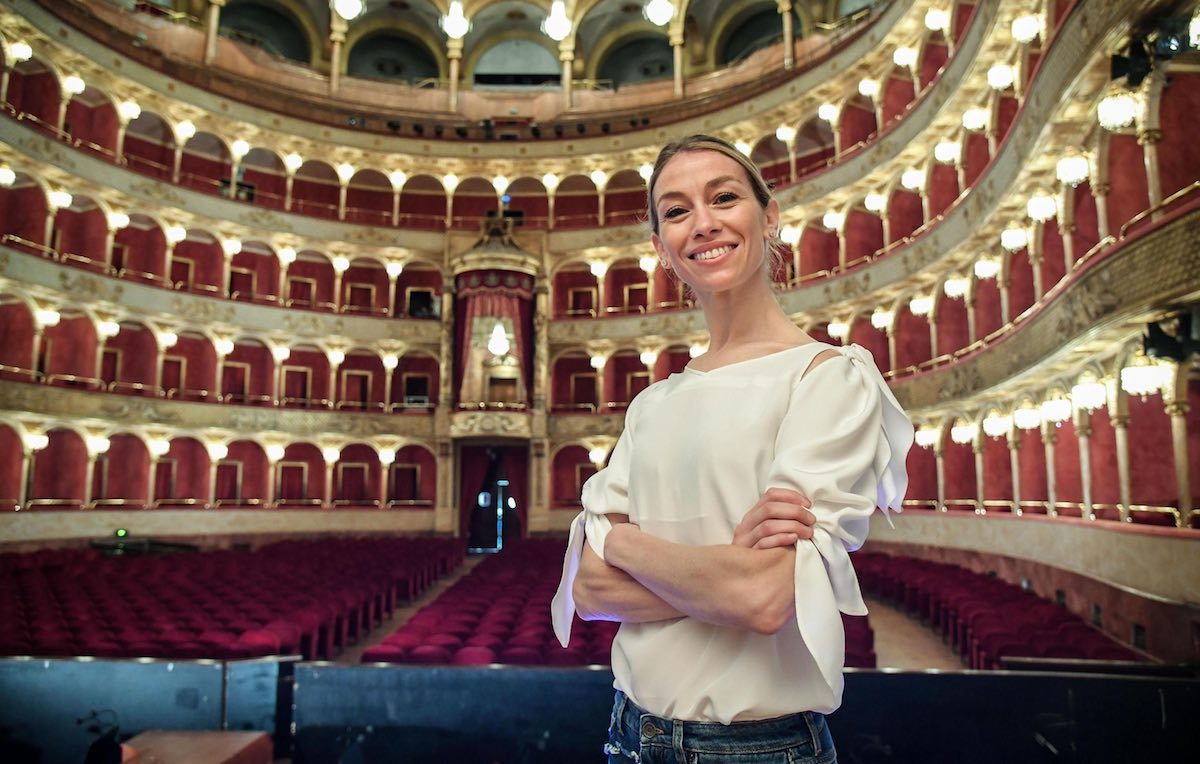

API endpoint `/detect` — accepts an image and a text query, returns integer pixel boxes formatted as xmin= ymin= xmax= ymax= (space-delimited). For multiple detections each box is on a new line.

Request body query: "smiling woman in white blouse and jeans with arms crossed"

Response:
xmin=553 ymin=136 xmax=913 ymax=764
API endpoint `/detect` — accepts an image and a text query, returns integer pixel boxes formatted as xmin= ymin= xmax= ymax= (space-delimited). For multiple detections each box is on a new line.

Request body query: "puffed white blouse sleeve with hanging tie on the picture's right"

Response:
xmin=767 ymin=345 xmax=913 ymax=691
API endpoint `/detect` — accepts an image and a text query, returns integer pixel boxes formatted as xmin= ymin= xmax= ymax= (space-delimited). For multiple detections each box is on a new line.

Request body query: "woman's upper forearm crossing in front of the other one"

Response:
xmin=605 ymin=524 xmax=796 ymax=633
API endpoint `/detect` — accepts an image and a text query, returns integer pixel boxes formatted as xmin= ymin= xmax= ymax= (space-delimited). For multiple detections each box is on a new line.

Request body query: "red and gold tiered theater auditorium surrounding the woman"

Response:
xmin=0 ymin=0 xmax=1200 ymax=764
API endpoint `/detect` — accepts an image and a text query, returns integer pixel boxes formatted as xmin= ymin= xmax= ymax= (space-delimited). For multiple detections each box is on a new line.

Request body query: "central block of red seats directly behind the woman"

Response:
xmin=362 ymin=539 xmax=875 ymax=668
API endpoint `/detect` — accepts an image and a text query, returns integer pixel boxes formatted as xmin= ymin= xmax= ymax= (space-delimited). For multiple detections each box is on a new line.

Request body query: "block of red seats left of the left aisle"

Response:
xmin=0 ymin=537 xmax=463 ymax=660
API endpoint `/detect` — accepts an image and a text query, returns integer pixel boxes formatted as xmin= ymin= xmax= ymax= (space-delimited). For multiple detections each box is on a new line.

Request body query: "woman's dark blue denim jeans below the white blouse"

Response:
xmin=604 ymin=690 xmax=838 ymax=764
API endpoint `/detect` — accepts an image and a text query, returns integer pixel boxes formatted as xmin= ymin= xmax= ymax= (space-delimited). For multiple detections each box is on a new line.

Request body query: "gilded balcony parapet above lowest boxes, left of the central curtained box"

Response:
xmin=0 ymin=381 xmax=434 ymax=443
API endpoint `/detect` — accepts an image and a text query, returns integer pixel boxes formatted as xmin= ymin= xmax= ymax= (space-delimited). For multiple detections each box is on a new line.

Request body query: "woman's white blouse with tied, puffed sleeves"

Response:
xmin=551 ymin=342 xmax=913 ymax=724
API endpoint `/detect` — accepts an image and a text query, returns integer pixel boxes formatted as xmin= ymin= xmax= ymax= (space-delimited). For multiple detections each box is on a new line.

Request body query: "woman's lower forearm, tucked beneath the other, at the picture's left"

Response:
xmin=571 ymin=542 xmax=683 ymax=624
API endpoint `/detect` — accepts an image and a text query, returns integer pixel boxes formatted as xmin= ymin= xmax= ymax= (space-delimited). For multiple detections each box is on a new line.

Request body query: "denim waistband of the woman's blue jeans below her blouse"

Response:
xmin=613 ymin=690 xmax=828 ymax=754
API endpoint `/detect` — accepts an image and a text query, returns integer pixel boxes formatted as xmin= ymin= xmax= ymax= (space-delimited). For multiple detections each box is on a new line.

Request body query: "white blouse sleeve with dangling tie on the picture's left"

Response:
xmin=550 ymin=392 xmax=646 ymax=648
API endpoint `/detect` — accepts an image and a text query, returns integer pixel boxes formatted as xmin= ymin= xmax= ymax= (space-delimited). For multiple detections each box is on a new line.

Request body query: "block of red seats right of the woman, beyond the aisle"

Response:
xmin=854 ymin=552 xmax=1146 ymax=669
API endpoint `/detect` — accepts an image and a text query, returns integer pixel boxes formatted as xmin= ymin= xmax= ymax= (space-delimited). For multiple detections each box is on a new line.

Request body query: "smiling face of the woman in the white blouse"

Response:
xmin=650 ymin=151 xmax=779 ymax=297
